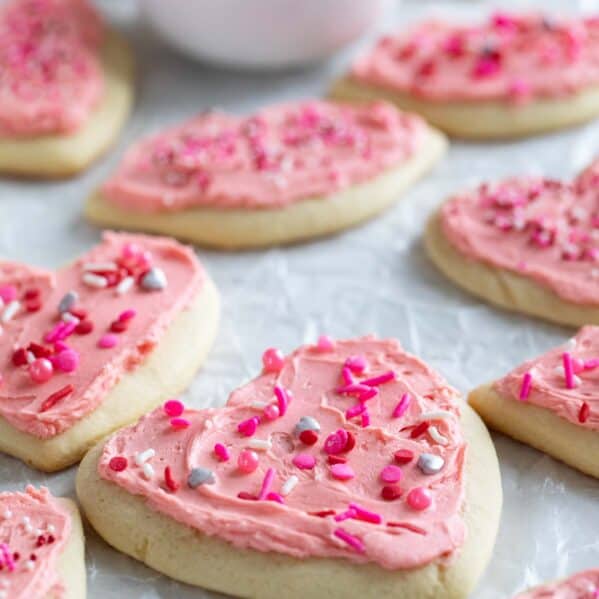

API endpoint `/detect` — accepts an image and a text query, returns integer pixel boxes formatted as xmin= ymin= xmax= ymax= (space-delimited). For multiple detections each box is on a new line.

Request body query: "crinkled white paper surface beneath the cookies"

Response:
xmin=0 ymin=0 xmax=599 ymax=599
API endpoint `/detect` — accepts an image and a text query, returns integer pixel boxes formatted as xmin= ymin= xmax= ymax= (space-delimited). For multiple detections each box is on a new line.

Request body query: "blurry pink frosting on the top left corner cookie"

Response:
xmin=0 ymin=0 xmax=104 ymax=138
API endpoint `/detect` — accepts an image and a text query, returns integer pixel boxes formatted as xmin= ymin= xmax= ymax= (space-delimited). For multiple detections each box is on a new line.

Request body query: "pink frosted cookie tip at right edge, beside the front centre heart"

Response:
xmin=469 ymin=326 xmax=599 ymax=478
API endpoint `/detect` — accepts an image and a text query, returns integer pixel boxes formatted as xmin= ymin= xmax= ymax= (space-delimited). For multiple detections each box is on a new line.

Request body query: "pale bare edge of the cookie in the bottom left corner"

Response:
xmin=47 ymin=498 xmax=87 ymax=599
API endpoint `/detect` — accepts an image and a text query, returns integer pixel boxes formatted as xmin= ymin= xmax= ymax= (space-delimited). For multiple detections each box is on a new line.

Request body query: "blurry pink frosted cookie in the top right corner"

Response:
xmin=332 ymin=13 xmax=599 ymax=139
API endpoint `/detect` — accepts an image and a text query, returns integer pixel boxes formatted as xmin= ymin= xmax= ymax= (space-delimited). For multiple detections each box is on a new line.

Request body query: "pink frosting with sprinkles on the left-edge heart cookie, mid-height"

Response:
xmin=0 ymin=233 xmax=205 ymax=439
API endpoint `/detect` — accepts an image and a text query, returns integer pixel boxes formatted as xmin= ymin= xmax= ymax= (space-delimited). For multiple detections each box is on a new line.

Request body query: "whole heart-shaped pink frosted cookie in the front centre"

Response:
xmin=77 ymin=337 xmax=502 ymax=599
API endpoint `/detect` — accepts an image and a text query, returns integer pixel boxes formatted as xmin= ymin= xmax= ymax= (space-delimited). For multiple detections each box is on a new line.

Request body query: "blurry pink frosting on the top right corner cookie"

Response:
xmin=352 ymin=13 xmax=599 ymax=102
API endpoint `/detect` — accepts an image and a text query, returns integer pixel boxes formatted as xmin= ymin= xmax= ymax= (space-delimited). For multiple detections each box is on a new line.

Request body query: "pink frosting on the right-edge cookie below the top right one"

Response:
xmin=441 ymin=161 xmax=599 ymax=305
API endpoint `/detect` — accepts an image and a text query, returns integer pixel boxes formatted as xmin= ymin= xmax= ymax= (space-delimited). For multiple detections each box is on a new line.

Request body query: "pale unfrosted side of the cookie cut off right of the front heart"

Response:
xmin=468 ymin=384 xmax=599 ymax=478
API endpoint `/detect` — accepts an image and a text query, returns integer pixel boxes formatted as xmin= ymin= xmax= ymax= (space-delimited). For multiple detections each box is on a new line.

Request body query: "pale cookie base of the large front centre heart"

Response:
xmin=76 ymin=403 xmax=502 ymax=599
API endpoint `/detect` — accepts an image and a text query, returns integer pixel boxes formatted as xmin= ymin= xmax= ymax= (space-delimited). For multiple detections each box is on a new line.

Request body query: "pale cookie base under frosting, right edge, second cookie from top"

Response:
xmin=424 ymin=212 xmax=599 ymax=326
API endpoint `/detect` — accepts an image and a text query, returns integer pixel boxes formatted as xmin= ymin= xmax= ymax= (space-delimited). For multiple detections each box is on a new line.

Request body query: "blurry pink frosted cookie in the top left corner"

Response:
xmin=0 ymin=0 xmax=133 ymax=177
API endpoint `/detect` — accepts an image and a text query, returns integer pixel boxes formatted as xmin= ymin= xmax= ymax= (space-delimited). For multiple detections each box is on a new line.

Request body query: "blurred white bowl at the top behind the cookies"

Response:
xmin=141 ymin=0 xmax=384 ymax=68
